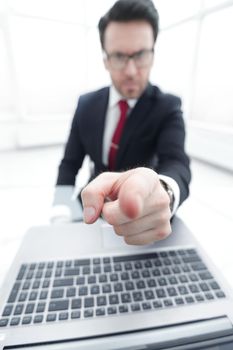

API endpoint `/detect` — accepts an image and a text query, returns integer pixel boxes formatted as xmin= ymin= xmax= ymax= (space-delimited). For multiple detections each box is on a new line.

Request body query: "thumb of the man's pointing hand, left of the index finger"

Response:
xmin=81 ymin=173 xmax=119 ymax=224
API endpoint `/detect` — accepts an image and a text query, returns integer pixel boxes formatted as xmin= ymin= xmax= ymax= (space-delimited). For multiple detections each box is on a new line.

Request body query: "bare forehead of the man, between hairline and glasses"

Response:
xmin=104 ymin=21 xmax=154 ymax=54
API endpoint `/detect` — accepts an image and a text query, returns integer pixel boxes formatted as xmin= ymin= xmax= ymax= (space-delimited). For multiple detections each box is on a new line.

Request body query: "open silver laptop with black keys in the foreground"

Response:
xmin=0 ymin=218 xmax=233 ymax=350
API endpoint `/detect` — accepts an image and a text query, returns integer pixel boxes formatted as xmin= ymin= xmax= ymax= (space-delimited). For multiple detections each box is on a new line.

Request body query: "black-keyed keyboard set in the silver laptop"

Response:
xmin=0 ymin=249 xmax=225 ymax=327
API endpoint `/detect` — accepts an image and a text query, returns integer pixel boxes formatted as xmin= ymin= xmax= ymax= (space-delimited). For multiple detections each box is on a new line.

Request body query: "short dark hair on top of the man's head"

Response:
xmin=98 ymin=0 xmax=159 ymax=48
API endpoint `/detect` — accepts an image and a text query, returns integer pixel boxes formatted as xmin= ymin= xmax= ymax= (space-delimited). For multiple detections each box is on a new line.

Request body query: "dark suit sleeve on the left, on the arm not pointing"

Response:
xmin=56 ymin=102 xmax=85 ymax=186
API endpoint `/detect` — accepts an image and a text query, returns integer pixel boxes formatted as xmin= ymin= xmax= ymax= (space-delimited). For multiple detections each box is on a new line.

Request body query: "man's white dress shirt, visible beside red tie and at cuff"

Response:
xmin=102 ymin=85 xmax=180 ymax=215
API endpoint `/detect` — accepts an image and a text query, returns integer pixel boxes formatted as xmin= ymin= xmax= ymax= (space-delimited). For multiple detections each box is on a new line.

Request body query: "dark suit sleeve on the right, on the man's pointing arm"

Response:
xmin=154 ymin=96 xmax=191 ymax=204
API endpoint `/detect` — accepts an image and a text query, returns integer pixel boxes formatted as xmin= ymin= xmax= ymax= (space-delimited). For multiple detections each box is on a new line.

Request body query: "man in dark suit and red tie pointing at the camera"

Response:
xmin=57 ymin=0 xmax=191 ymax=244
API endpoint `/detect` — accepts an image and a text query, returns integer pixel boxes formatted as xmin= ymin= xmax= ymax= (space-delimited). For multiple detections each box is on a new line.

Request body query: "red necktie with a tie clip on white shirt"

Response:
xmin=108 ymin=100 xmax=129 ymax=171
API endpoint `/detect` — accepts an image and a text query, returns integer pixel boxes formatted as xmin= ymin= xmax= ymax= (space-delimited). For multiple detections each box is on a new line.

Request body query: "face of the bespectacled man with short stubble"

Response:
xmin=104 ymin=21 xmax=154 ymax=98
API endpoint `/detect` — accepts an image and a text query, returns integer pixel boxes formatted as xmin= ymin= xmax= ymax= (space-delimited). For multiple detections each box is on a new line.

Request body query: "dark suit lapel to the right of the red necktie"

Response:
xmin=116 ymin=84 xmax=153 ymax=168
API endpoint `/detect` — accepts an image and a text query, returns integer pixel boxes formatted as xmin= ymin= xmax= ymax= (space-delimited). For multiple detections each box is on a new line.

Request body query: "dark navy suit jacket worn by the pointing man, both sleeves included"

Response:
xmin=57 ymin=84 xmax=191 ymax=204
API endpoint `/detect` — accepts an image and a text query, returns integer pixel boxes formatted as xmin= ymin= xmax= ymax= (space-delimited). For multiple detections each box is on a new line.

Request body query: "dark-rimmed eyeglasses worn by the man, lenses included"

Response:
xmin=105 ymin=49 xmax=154 ymax=70
